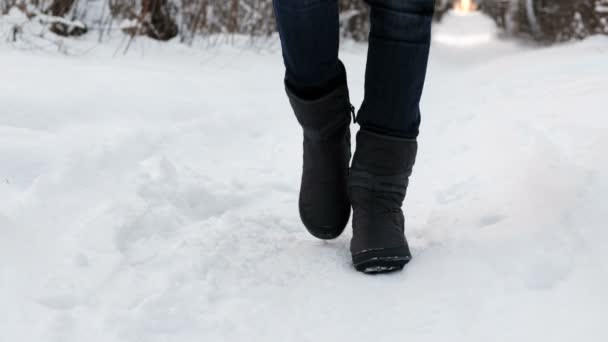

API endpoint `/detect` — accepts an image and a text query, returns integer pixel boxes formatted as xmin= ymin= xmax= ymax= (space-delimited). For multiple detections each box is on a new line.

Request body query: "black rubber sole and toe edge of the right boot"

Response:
xmin=353 ymin=247 xmax=412 ymax=274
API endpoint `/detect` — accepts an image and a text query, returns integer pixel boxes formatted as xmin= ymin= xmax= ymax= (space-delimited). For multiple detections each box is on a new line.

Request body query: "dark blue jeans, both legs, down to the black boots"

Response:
xmin=273 ymin=0 xmax=434 ymax=138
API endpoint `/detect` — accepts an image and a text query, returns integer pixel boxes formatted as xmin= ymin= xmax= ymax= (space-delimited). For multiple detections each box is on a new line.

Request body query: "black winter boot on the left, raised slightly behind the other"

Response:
xmin=287 ymin=86 xmax=352 ymax=240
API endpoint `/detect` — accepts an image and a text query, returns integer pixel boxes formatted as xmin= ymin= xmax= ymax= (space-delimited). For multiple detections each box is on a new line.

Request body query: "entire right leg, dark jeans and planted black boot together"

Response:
xmin=349 ymin=0 xmax=434 ymax=273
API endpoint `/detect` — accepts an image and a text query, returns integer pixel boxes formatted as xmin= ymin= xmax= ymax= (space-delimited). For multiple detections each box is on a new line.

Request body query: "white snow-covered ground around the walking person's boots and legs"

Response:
xmin=0 ymin=12 xmax=608 ymax=342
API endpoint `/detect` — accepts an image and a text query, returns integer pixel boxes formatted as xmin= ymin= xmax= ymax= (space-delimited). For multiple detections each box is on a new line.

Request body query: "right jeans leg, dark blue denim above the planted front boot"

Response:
xmin=358 ymin=0 xmax=434 ymax=138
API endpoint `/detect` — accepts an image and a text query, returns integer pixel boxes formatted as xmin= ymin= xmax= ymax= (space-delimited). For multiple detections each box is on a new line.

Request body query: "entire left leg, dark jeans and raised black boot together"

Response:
xmin=274 ymin=0 xmax=351 ymax=239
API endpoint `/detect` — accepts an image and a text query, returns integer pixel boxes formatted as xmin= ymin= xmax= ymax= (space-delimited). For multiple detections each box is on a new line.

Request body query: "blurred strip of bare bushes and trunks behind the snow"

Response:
xmin=0 ymin=0 xmax=608 ymax=44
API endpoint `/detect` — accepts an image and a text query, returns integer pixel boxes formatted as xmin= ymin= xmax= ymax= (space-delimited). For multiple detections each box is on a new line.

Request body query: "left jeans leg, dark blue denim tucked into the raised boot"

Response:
xmin=273 ymin=0 xmax=346 ymax=99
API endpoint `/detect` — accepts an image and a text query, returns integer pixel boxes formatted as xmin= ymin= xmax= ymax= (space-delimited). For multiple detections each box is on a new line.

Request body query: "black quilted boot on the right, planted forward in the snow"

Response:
xmin=349 ymin=130 xmax=418 ymax=273
